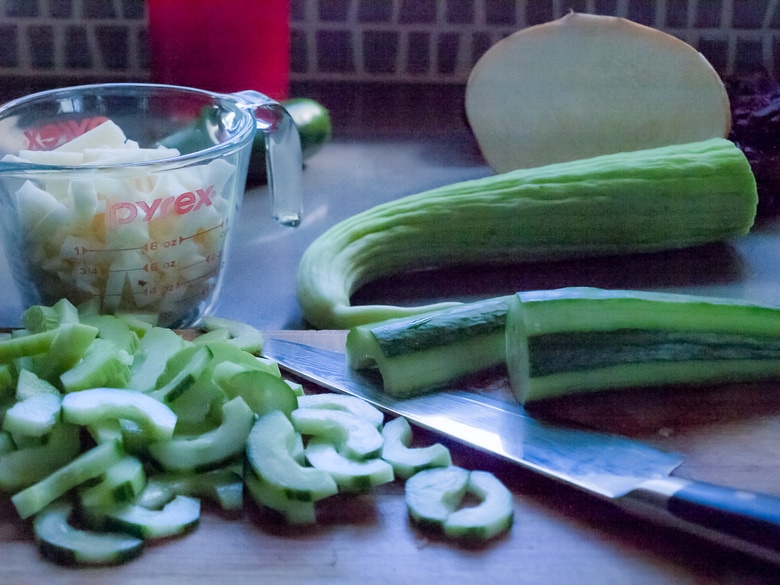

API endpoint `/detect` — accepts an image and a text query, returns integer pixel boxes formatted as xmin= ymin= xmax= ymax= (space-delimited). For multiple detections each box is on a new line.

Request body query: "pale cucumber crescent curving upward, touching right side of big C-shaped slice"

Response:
xmin=305 ymin=437 xmax=395 ymax=492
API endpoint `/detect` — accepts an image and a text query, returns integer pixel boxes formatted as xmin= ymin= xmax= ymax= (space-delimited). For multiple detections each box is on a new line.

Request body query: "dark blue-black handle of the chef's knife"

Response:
xmin=618 ymin=477 xmax=780 ymax=563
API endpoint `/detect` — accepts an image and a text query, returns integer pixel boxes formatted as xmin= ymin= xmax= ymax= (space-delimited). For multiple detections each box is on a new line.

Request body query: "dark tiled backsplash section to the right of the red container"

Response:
xmin=292 ymin=0 xmax=780 ymax=83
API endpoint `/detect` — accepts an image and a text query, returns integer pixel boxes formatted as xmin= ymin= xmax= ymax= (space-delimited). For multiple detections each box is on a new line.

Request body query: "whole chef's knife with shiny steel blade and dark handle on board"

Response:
xmin=263 ymin=338 xmax=780 ymax=563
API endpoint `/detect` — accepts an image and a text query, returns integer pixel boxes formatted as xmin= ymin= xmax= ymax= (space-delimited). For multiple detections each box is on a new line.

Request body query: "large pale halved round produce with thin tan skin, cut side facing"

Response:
xmin=465 ymin=12 xmax=731 ymax=173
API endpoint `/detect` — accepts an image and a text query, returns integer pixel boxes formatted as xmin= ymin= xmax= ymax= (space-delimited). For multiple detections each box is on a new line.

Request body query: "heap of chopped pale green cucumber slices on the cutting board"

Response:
xmin=0 ymin=301 xmax=514 ymax=565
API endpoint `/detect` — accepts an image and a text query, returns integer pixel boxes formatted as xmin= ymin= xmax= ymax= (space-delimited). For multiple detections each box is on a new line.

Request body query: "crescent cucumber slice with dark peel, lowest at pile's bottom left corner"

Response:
xmin=33 ymin=500 xmax=144 ymax=565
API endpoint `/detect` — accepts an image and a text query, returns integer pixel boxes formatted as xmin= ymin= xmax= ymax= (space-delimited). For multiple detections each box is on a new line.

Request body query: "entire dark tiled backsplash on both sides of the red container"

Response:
xmin=0 ymin=0 xmax=780 ymax=90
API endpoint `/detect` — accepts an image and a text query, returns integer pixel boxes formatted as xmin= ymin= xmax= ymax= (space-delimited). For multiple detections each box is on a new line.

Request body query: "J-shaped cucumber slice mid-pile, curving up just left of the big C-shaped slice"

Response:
xmin=149 ymin=396 xmax=254 ymax=471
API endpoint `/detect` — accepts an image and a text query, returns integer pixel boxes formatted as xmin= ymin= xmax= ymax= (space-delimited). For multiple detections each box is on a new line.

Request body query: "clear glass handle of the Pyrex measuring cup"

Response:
xmin=234 ymin=90 xmax=303 ymax=227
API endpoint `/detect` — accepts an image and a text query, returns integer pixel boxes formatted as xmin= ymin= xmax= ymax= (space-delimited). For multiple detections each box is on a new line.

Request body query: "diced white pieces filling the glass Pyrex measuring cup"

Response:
xmin=4 ymin=120 xmax=236 ymax=325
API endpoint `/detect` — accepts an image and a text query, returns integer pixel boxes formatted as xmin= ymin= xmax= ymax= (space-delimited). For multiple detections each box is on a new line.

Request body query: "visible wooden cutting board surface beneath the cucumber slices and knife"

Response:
xmin=0 ymin=331 xmax=780 ymax=585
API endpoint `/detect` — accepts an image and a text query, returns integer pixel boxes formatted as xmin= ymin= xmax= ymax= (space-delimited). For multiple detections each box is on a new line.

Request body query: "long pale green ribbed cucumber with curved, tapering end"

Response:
xmin=296 ymin=138 xmax=757 ymax=329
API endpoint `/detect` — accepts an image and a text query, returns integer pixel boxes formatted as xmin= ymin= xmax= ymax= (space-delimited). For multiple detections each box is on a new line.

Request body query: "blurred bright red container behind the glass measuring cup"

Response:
xmin=147 ymin=0 xmax=290 ymax=100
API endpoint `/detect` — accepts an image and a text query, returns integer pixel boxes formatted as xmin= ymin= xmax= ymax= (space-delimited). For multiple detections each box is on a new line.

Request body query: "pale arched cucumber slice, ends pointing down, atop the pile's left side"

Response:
xmin=62 ymin=388 xmax=176 ymax=441
